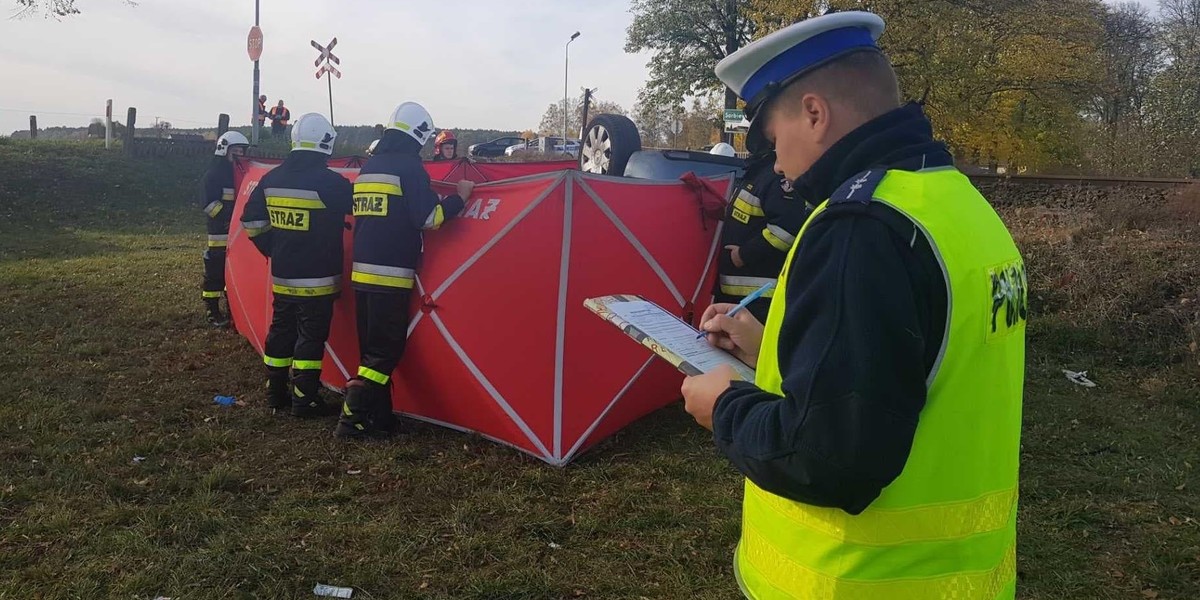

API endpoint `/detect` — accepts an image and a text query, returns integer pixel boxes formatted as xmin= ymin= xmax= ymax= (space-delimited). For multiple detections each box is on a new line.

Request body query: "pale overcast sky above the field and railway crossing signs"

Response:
xmin=0 ymin=0 xmax=1156 ymax=136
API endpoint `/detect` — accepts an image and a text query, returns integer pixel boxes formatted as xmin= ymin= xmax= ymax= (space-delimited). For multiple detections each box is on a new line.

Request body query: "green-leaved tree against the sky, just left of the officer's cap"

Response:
xmin=625 ymin=0 xmax=756 ymax=108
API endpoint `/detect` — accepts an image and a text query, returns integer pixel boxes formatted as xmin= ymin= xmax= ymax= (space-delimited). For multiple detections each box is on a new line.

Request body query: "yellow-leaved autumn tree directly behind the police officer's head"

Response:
xmin=751 ymin=0 xmax=1104 ymax=168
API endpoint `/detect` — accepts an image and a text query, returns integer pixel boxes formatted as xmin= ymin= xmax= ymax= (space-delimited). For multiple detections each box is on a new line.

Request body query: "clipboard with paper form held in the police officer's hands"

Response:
xmin=583 ymin=295 xmax=755 ymax=382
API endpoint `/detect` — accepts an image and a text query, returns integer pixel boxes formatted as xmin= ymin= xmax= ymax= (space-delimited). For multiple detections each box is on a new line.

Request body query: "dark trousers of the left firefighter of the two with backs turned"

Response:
xmin=263 ymin=295 xmax=335 ymax=397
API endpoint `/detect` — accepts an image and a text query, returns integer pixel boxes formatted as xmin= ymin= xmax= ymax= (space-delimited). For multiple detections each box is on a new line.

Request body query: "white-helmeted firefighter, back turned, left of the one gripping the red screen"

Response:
xmin=241 ymin=113 xmax=353 ymax=418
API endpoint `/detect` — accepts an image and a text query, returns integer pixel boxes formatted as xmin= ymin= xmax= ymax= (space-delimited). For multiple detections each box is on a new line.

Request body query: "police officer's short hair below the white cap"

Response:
xmin=772 ymin=50 xmax=901 ymax=120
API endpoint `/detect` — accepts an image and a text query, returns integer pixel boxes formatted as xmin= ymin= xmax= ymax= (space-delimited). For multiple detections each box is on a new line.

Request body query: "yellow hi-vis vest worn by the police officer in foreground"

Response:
xmin=734 ymin=168 xmax=1027 ymax=600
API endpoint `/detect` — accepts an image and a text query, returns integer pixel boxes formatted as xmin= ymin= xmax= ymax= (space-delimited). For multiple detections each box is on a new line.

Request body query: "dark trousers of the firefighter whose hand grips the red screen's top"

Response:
xmin=354 ymin=290 xmax=413 ymax=385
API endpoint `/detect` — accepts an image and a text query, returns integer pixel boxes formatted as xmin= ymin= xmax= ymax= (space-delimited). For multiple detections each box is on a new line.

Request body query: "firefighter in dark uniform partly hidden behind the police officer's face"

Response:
xmin=712 ymin=143 xmax=809 ymax=320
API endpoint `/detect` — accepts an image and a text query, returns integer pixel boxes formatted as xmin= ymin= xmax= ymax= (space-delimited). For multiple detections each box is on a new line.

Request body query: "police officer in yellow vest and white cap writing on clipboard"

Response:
xmin=683 ymin=12 xmax=1027 ymax=600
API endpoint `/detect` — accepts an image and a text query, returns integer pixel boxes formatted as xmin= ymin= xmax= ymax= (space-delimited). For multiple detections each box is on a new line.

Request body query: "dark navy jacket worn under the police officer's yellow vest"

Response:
xmin=713 ymin=104 xmax=953 ymax=514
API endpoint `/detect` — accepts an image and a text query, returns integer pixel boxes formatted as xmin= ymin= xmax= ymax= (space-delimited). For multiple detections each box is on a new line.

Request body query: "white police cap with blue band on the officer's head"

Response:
xmin=716 ymin=11 xmax=883 ymax=148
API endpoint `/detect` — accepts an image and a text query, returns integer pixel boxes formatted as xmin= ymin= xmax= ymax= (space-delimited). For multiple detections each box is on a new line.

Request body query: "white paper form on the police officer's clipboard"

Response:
xmin=608 ymin=300 xmax=754 ymax=382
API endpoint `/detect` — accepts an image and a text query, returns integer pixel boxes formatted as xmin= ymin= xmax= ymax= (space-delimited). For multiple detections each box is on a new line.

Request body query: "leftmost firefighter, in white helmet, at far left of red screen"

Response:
xmin=200 ymin=131 xmax=250 ymax=328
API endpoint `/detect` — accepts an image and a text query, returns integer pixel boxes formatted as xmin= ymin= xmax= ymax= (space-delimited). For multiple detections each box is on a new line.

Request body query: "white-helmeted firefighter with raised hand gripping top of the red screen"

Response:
xmin=334 ymin=102 xmax=475 ymax=439
